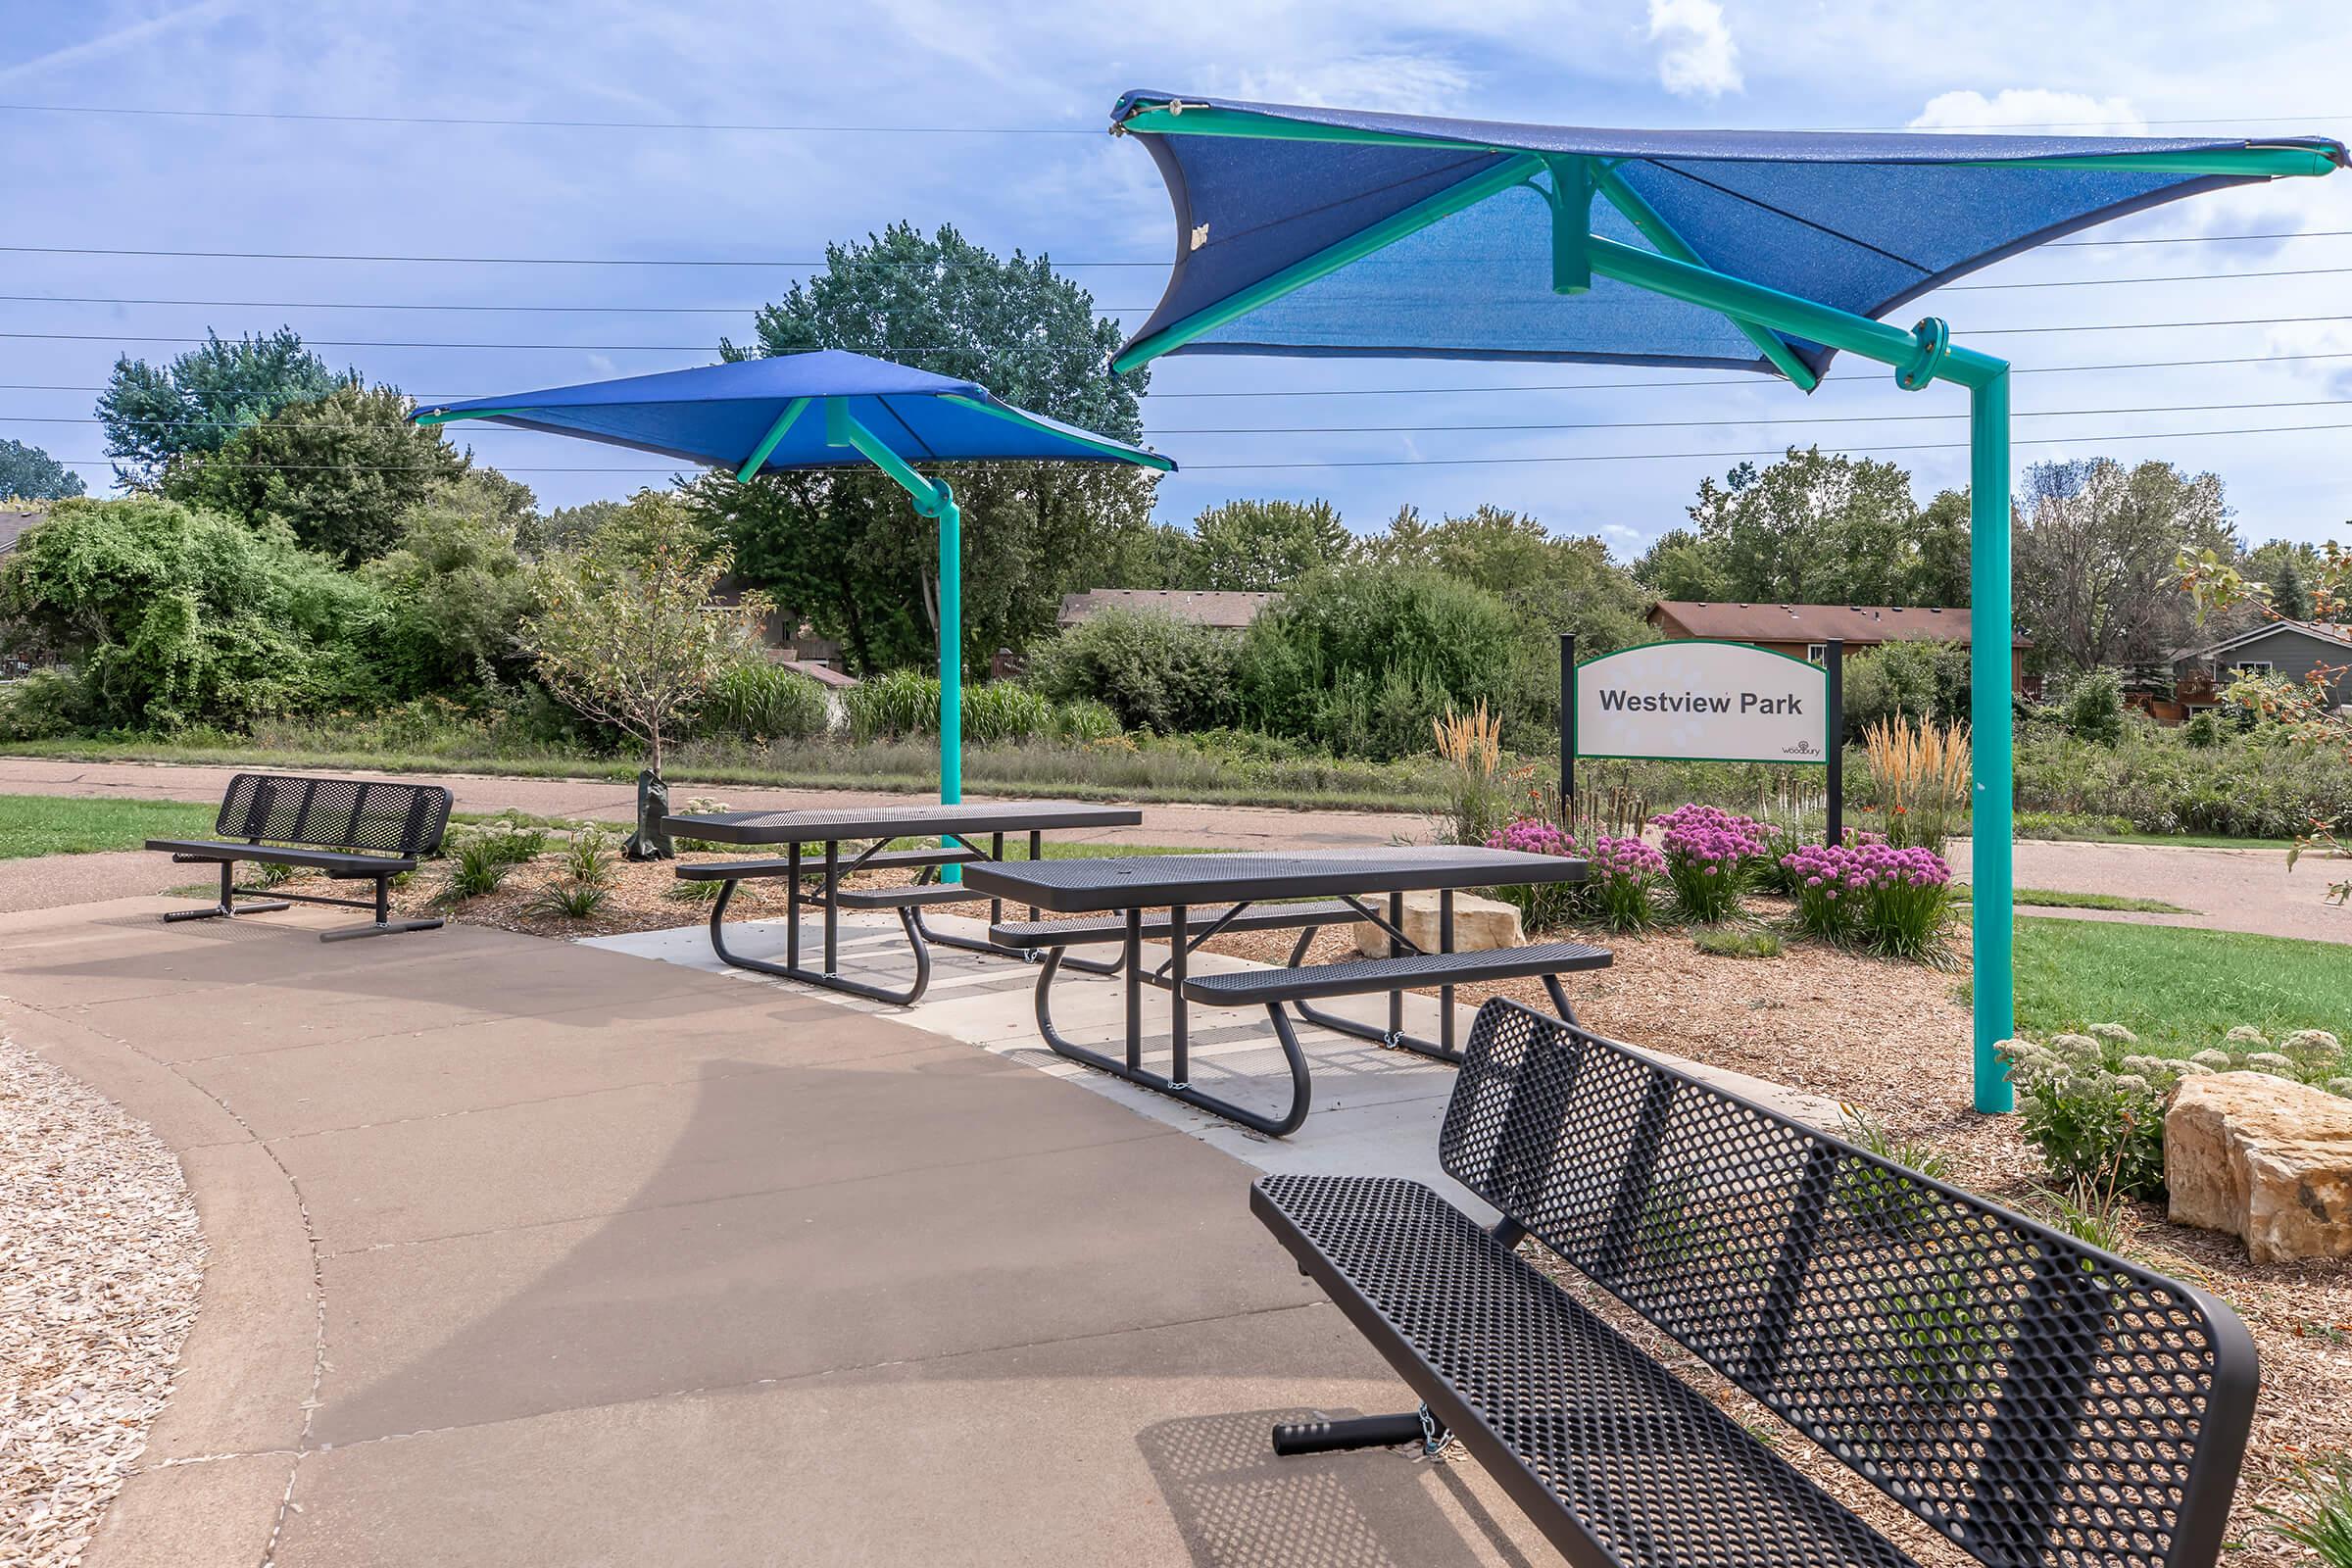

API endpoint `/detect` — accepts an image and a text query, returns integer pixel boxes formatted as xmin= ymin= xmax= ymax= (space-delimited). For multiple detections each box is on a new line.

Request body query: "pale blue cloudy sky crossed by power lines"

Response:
xmin=0 ymin=0 xmax=2352 ymax=553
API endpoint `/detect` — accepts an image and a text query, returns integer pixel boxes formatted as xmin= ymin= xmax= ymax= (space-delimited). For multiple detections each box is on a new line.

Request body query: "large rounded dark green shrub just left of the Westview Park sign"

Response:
xmin=1237 ymin=566 xmax=1524 ymax=757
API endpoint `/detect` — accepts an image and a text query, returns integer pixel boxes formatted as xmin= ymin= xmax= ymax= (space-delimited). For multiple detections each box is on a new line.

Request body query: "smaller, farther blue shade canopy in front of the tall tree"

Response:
xmin=416 ymin=348 xmax=1176 ymax=477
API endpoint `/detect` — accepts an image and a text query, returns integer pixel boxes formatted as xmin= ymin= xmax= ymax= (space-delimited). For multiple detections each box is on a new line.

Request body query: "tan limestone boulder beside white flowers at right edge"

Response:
xmin=2164 ymin=1072 xmax=2352 ymax=1262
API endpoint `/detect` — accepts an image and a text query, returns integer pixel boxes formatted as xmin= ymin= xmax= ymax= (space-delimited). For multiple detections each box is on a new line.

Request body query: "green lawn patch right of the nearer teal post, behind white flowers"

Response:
xmin=2016 ymin=917 xmax=2352 ymax=1051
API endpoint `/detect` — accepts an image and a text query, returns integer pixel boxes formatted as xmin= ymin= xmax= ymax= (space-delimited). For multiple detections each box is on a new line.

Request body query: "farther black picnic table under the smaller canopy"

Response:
xmin=663 ymin=802 xmax=1143 ymax=1006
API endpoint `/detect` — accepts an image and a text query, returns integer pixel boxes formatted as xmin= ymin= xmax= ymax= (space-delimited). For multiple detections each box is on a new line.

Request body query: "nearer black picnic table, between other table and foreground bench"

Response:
xmin=964 ymin=844 xmax=1609 ymax=1138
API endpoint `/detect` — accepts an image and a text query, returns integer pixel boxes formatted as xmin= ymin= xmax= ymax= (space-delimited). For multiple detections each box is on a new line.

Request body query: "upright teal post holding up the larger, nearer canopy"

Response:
xmin=1969 ymin=367 xmax=2018 ymax=1112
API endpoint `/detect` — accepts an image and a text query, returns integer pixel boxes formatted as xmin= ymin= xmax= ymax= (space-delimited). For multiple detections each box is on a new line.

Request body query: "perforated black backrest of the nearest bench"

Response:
xmin=1440 ymin=999 xmax=2256 ymax=1568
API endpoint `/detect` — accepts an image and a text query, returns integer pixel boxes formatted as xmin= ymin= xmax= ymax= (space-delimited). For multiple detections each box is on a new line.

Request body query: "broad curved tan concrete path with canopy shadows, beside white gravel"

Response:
xmin=0 ymin=901 xmax=1552 ymax=1568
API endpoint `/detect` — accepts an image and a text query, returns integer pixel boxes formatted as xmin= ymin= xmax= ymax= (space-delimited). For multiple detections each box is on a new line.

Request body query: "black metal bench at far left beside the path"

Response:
xmin=146 ymin=773 xmax=452 ymax=943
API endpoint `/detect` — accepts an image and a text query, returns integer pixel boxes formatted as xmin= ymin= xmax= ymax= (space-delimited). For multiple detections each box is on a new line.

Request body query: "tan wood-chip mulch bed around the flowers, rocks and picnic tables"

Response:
xmin=267 ymin=856 xmax=2352 ymax=1568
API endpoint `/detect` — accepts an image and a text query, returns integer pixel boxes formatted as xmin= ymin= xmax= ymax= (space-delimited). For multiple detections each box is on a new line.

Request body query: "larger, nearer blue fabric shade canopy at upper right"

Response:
xmin=1112 ymin=92 xmax=2345 ymax=388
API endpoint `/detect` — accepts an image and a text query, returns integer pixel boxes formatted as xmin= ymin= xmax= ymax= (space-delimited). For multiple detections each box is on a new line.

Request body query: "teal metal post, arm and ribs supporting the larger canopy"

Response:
xmin=1112 ymin=101 xmax=2335 ymax=1112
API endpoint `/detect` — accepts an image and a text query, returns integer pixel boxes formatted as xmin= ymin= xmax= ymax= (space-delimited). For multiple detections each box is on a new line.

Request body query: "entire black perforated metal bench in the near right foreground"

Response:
xmin=1251 ymin=999 xmax=2258 ymax=1568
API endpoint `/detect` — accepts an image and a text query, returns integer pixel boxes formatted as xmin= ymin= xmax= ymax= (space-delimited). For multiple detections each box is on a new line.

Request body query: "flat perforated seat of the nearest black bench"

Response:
xmin=1249 ymin=1175 xmax=1912 ymax=1568
